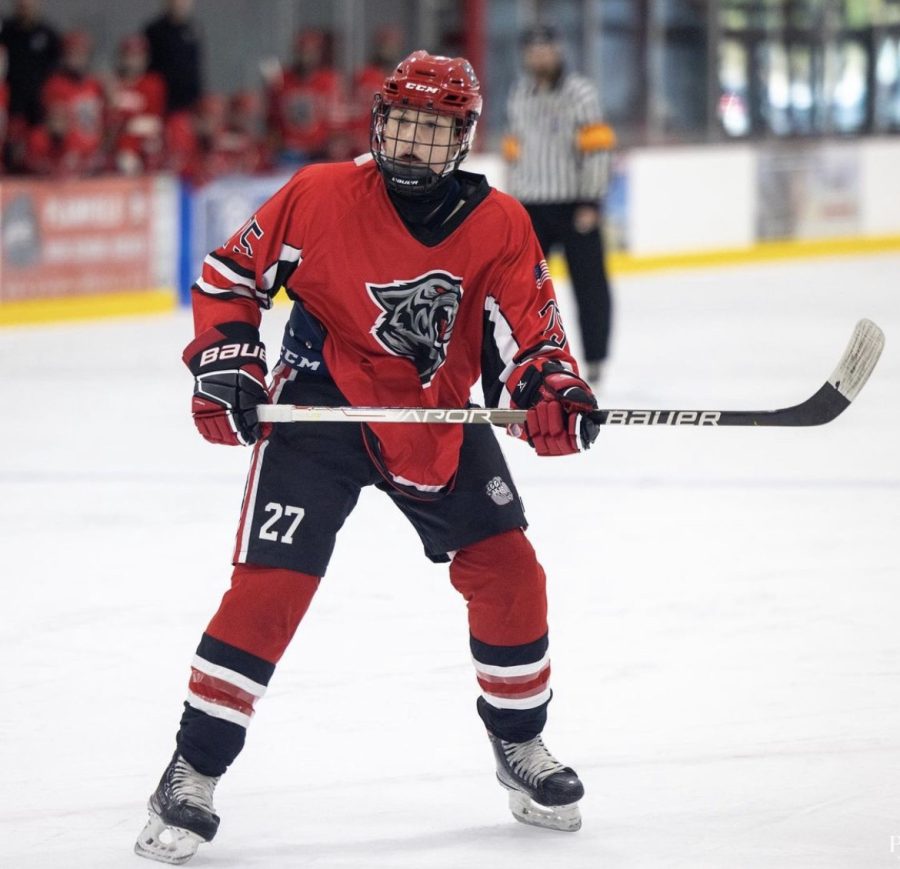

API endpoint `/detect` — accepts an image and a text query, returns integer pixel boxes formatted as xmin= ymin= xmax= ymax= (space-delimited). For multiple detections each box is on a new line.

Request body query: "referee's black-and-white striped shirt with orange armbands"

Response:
xmin=503 ymin=72 xmax=615 ymax=203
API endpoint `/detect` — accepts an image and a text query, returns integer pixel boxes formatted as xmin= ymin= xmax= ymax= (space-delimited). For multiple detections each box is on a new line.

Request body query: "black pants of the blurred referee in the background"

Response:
xmin=523 ymin=202 xmax=612 ymax=362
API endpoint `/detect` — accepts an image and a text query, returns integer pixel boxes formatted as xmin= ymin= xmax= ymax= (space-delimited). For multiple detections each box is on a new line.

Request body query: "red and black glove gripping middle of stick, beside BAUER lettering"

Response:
xmin=512 ymin=362 xmax=600 ymax=456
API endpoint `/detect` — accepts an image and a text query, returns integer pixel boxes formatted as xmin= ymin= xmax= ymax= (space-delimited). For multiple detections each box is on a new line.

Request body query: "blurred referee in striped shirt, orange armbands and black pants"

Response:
xmin=503 ymin=25 xmax=615 ymax=386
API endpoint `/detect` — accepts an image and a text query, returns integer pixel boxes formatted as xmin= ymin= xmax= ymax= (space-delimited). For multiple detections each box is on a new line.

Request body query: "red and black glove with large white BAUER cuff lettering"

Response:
xmin=182 ymin=322 xmax=271 ymax=446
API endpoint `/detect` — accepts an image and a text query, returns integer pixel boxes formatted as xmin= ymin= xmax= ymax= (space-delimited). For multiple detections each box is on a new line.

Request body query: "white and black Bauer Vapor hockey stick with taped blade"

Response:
xmin=257 ymin=320 xmax=884 ymax=426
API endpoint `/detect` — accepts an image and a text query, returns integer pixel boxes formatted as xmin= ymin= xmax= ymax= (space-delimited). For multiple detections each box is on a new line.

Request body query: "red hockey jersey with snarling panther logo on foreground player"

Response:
xmin=194 ymin=158 xmax=575 ymax=494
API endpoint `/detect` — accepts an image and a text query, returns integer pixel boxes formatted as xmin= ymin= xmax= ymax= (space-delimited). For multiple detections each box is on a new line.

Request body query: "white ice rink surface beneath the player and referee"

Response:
xmin=0 ymin=255 xmax=900 ymax=869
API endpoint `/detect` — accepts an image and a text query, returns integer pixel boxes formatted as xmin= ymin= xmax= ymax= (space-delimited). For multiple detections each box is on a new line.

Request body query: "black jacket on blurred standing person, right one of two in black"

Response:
xmin=144 ymin=15 xmax=203 ymax=112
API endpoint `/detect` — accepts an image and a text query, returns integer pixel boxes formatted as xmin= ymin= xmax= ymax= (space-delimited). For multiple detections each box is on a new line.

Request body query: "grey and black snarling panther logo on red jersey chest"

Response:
xmin=366 ymin=271 xmax=463 ymax=386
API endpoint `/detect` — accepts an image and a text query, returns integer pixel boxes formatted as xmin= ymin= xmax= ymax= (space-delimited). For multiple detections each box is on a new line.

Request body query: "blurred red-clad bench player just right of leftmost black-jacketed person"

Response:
xmin=41 ymin=30 xmax=106 ymax=173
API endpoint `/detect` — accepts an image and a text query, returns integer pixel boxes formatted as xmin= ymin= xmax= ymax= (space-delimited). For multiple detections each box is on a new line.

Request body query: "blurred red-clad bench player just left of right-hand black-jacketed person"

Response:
xmin=107 ymin=33 xmax=166 ymax=175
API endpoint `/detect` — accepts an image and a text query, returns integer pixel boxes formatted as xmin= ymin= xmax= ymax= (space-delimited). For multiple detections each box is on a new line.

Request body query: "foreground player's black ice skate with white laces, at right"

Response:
xmin=488 ymin=733 xmax=584 ymax=833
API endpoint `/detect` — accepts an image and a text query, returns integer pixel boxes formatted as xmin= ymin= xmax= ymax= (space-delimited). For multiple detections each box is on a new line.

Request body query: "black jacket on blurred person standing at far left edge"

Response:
xmin=0 ymin=17 xmax=61 ymax=124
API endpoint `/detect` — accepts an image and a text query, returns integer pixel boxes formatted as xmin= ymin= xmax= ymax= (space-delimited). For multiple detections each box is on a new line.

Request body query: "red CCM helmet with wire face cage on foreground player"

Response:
xmin=370 ymin=51 xmax=481 ymax=195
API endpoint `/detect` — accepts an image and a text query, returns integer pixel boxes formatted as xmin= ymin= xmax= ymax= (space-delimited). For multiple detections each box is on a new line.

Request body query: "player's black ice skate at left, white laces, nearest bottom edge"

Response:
xmin=134 ymin=754 xmax=219 ymax=865
